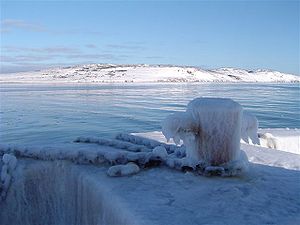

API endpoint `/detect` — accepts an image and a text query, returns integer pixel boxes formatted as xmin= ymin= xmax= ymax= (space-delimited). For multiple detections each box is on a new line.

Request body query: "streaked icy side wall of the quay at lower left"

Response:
xmin=0 ymin=159 xmax=144 ymax=225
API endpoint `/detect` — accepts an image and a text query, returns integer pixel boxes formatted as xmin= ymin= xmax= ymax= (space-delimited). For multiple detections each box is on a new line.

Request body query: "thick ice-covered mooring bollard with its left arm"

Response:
xmin=162 ymin=98 xmax=242 ymax=166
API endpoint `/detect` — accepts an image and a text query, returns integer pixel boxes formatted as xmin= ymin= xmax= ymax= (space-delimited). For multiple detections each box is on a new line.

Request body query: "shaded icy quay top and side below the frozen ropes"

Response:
xmin=0 ymin=156 xmax=300 ymax=225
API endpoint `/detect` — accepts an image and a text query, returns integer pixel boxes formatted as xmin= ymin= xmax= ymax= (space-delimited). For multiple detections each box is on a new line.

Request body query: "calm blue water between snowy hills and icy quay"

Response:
xmin=0 ymin=84 xmax=300 ymax=145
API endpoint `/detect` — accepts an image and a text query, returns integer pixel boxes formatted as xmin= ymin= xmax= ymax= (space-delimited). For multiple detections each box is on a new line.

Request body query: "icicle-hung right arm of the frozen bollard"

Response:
xmin=241 ymin=111 xmax=260 ymax=145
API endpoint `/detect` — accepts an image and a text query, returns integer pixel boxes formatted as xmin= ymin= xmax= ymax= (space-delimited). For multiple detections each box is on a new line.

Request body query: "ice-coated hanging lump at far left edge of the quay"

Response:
xmin=0 ymin=154 xmax=17 ymax=200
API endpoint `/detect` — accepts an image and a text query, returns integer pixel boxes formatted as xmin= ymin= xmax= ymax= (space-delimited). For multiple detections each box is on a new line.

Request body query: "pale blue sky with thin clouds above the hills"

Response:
xmin=0 ymin=0 xmax=300 ymax=75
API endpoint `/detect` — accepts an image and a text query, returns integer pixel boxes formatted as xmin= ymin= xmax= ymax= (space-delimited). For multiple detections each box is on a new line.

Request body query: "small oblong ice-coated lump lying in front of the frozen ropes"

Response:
xmin=107 ymin=162 xmax=140 ymax=177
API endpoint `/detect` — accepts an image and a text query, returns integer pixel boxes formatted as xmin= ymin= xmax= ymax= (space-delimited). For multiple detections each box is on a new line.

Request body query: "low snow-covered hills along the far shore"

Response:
xmin=0 ymin=64 xmax=300 ymax=84
